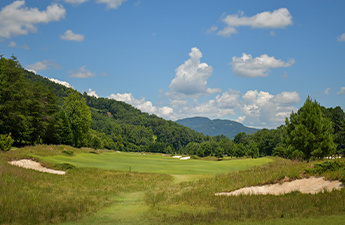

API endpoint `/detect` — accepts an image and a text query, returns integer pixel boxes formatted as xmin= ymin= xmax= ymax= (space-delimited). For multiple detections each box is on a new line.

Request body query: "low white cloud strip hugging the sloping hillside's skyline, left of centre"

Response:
xmin=108 ymin=93 xmax=173 ymax=118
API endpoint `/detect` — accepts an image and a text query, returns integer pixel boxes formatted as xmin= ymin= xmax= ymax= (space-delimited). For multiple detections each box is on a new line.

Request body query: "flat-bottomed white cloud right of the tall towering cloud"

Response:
xmin=230 ymin=53 xmax=295 ymax=77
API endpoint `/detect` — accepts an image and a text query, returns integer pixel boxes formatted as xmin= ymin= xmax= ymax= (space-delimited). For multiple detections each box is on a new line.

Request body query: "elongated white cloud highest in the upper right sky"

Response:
xmin=217 ymin=8 xmax=292 ymax=37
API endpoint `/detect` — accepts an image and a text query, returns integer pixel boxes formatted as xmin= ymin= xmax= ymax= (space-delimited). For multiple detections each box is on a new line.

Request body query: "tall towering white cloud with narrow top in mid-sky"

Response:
xmin=168 ymin=48 xmax=221 ymax=98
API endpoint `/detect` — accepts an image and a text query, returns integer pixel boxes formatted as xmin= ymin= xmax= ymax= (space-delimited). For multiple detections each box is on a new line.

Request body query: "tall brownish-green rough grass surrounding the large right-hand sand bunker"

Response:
xmin=145 ymin=159 xmax=345 ymax=224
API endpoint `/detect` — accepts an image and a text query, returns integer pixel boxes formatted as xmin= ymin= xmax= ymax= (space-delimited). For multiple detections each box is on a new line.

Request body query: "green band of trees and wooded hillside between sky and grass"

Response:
xmin=0 ymin=56 xmax=345 ymax=160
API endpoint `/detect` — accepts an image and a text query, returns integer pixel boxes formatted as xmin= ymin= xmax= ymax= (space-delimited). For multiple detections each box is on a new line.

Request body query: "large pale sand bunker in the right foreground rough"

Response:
xmin=216 ymin=177 xmax=344 ymax=196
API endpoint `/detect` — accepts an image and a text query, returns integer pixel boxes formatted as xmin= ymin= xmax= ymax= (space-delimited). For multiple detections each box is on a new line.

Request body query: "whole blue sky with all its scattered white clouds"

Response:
xmin=0 ymin=0 xmax=345 ymax=128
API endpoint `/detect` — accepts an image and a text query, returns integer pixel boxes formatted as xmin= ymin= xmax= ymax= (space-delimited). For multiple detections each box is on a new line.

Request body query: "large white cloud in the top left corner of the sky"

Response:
xmin=0 ymin=1 xmax=66 ymax=38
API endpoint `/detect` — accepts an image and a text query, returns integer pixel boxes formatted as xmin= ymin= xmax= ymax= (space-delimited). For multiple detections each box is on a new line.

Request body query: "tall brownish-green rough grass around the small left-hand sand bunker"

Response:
xmin=0 ymin=145 xmax=172 ymax=224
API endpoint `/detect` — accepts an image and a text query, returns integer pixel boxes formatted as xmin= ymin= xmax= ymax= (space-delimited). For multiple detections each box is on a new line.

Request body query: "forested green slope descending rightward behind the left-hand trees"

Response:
xmin=24 ymin=71 xmax=205 ymax=151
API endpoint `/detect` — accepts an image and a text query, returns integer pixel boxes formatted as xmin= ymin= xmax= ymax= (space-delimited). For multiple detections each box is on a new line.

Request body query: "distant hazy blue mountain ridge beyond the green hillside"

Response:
xmin=176 ymin=117 xmax=259 ymax=139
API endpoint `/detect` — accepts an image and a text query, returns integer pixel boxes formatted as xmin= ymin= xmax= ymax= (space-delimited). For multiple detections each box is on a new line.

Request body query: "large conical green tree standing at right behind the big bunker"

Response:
xmin=282 ymin=97 xmax=336 ymax=160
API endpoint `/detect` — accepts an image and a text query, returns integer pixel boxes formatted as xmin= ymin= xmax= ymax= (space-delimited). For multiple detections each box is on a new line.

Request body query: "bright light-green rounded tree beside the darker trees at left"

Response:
xmin=64 ymin=92 xmax=91 ymax=147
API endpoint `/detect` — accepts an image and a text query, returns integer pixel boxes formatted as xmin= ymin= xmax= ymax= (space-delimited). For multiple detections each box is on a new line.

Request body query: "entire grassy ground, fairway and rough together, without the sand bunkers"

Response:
xmin=0 ymin=146 xmax=345 ymax=225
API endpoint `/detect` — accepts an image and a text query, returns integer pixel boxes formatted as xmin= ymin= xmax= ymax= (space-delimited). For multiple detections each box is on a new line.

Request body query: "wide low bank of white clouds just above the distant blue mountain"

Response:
xmin=168 ymin=89 xmax=300 ymax=128
